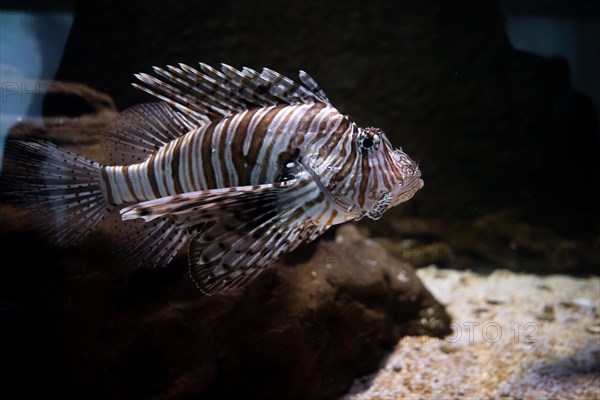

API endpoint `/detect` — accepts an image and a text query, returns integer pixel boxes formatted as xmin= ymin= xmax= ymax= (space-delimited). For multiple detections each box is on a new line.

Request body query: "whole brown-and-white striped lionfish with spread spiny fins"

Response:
xmin=3 ymin=63 xmax=423 ymax=294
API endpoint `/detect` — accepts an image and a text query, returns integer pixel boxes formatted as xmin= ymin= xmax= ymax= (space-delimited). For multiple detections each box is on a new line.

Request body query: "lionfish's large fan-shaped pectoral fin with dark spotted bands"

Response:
xmin=121 ymin=179 xmax=322 ymax=294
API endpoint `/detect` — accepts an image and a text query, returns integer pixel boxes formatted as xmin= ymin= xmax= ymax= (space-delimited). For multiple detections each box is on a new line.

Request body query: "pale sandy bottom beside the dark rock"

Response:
xmin=344 ymin=267 xmax=600 ymax=400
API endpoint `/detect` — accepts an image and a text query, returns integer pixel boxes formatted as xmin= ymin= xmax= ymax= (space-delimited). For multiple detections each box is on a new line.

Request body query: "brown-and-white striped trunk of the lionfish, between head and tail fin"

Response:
xmin=102 ymin=103 xmax=340 ymax=205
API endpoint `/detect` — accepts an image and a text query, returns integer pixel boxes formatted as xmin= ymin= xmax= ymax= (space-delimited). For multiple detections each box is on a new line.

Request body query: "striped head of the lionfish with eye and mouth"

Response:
xmin=329 ymin=124 xmax=423 ymax=219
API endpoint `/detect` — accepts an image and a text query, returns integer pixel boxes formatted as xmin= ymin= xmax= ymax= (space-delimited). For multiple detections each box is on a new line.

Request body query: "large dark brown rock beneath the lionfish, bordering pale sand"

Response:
xmin=0 ymin=220 xmax=449 ymax=399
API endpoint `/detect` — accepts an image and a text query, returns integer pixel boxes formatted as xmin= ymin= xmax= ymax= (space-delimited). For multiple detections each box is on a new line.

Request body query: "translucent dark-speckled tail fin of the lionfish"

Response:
xmin=0 ymin=138 xmax=112 ymax=246
